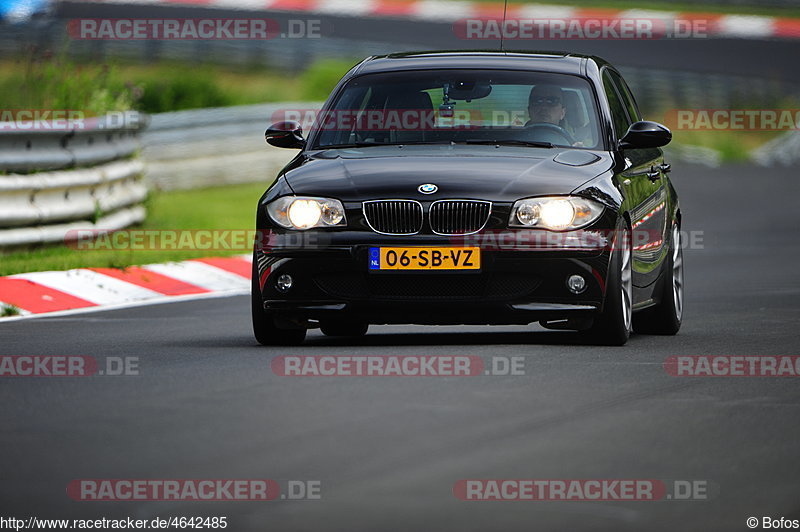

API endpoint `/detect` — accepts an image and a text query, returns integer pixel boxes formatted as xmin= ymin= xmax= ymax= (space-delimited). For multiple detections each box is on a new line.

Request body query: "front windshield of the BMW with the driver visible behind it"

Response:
xmin=311 ymin=70 xmax=601 ymax=149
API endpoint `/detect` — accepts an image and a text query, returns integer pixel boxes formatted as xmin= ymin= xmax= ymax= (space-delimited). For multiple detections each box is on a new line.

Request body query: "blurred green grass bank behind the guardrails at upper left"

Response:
xmin=0 ymin=54 xmax=355 ymax=115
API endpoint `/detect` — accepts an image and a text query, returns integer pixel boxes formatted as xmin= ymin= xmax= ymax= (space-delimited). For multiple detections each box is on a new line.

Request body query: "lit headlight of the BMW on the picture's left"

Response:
xmin=267 ymin=196 xmax=347 ymax=229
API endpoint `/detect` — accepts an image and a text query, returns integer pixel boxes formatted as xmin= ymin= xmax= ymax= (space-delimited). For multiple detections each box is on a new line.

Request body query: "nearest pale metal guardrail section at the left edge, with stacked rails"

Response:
xmin=0 ymin=113 xmax=147 ymax=247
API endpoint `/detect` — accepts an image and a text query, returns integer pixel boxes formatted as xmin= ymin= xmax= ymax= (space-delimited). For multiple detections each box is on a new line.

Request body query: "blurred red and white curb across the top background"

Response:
xmin=79 ymin=0 xmax=800 ymax=39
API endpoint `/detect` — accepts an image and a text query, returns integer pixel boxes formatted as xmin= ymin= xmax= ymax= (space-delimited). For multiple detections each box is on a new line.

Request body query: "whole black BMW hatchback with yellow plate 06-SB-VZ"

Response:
xmin=252 ymin=52 xmax=683 ymax=345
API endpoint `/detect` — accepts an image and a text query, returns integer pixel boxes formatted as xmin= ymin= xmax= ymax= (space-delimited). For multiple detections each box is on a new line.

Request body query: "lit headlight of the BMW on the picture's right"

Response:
xmin=508 ymin=196 xmax=604 ymax=231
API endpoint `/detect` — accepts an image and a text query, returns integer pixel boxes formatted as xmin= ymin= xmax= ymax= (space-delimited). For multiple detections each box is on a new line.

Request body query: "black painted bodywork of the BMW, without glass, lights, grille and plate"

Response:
xmin=254 ymin=52 xmax=680 ymax=328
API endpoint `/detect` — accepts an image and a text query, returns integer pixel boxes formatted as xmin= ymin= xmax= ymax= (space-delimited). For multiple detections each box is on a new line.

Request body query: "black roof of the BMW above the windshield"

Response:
xmin=352 ymin=50 xmax=608 ymax=77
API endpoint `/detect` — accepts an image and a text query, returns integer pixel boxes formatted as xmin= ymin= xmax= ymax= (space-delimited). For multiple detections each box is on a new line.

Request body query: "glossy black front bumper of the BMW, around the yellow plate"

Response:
xmin=255 ymin=231 xmax=609 ymax=325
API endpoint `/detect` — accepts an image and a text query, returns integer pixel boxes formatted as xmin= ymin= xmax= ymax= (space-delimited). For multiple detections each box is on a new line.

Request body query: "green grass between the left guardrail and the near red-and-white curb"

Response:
xmin=0 ymin=183 xmax=268 ymax=275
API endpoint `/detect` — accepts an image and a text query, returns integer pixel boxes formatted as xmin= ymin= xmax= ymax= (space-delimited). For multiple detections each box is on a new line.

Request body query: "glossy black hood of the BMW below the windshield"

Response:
xmin=285 ymin=145 xmax=612 ymax=202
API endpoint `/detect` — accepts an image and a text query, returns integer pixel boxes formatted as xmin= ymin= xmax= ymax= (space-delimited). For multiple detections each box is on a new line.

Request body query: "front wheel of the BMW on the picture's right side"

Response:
xmin=586 ymin=226 xmax=633 ymax=346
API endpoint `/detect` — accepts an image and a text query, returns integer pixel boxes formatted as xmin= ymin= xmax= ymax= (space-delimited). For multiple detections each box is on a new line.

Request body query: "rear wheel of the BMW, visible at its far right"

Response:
xmin=633 ymin=224 xmax=683 ymax=336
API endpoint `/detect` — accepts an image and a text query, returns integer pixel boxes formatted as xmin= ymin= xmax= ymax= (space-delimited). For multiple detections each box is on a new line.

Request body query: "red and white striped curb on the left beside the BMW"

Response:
xmin=0 ymin=255 xmax=252 ymax=323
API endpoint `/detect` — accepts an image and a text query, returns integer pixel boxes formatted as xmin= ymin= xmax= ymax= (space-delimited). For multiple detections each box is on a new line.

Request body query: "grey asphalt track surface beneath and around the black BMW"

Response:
xmin=0 ymin=160 xmax=800 ymax=531
